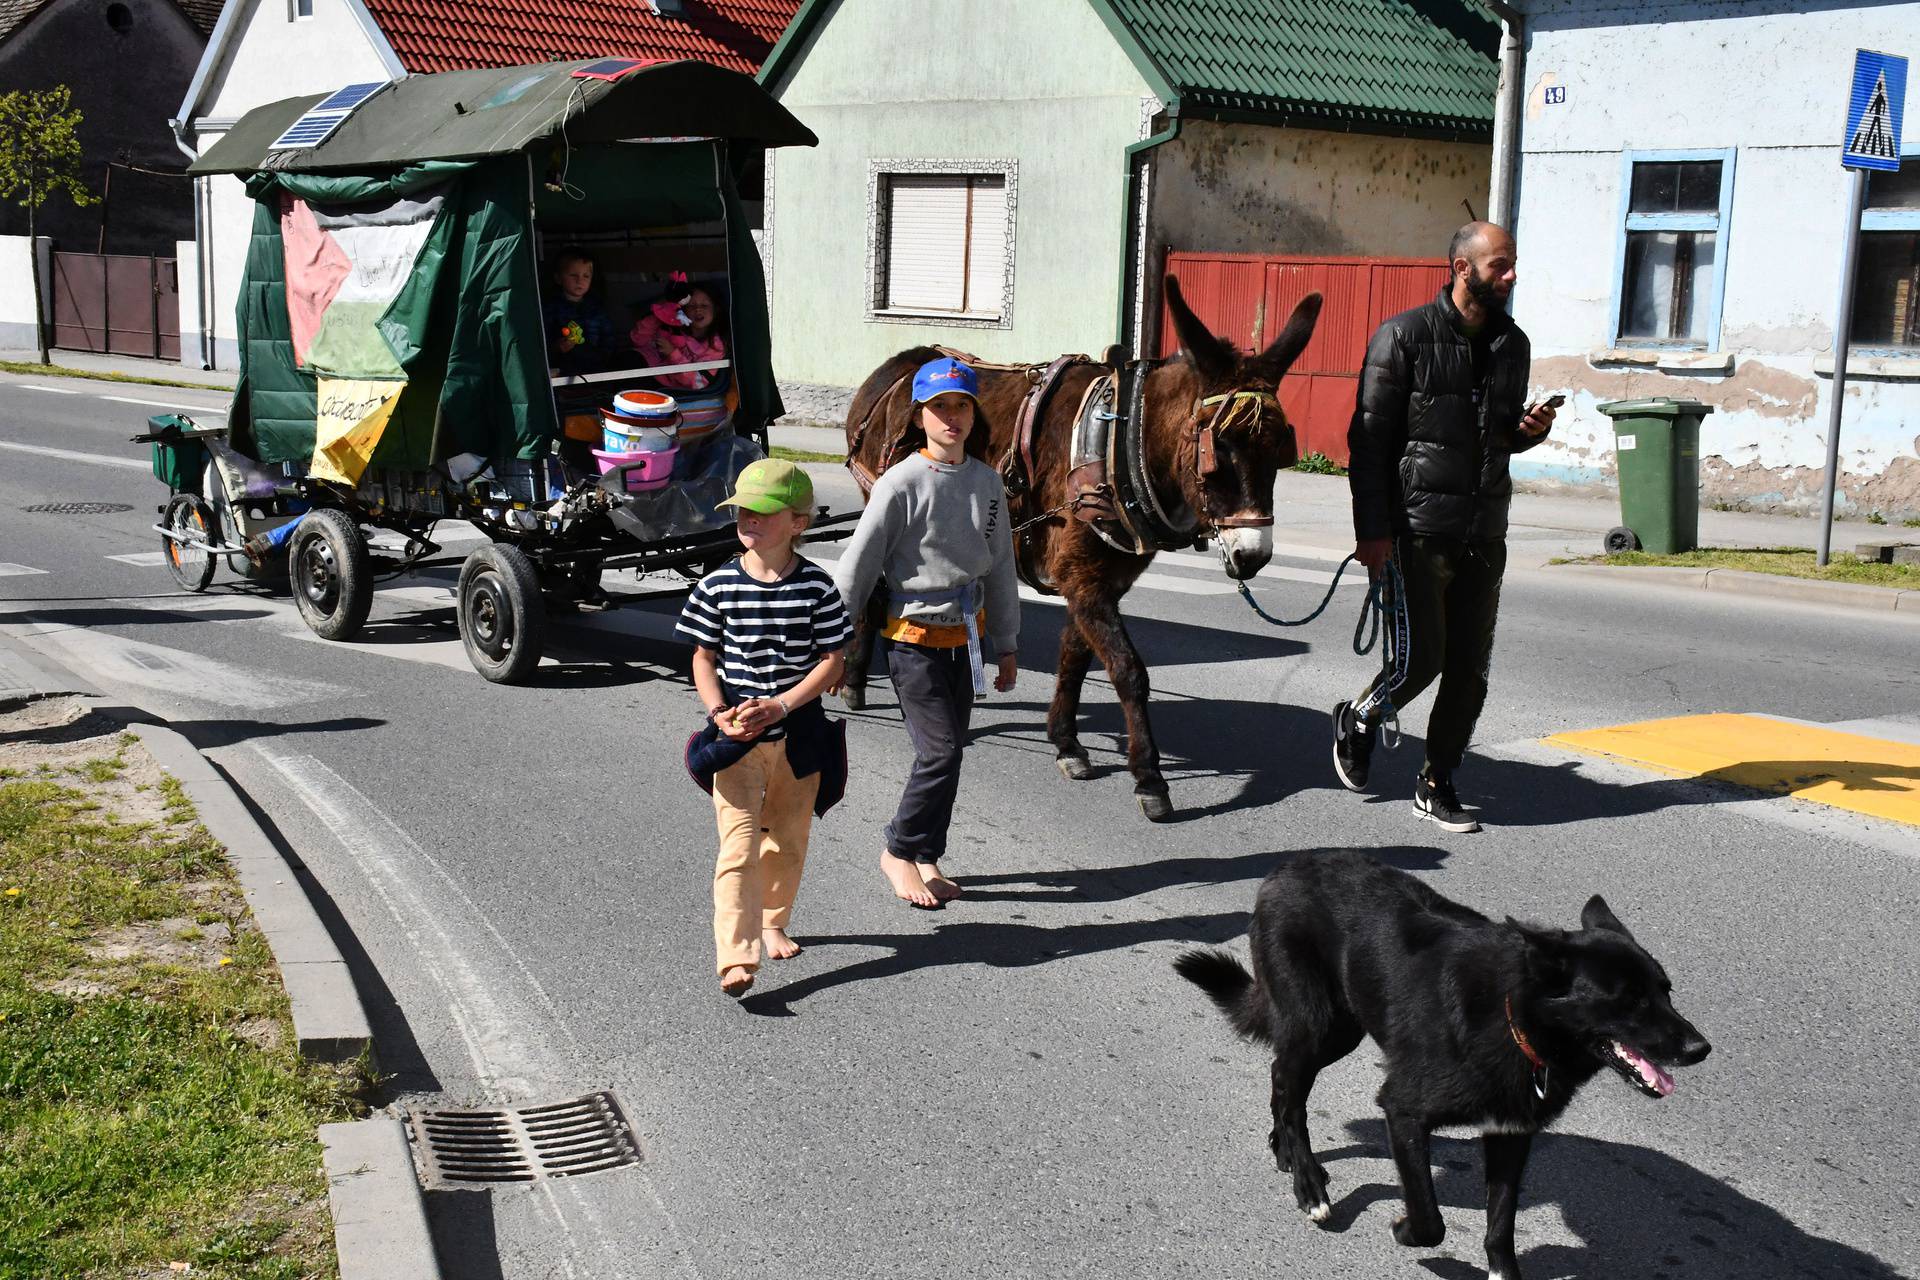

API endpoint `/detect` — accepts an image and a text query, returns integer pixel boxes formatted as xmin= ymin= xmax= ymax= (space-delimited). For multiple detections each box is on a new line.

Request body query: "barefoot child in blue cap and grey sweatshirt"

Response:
xmin=833 ymin=359 xmax=1020 ymax=910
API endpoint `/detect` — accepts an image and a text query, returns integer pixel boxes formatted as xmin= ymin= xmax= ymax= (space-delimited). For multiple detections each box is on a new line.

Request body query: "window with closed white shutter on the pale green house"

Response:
xmin=870 ymin=161 xmax=1016 ymax=328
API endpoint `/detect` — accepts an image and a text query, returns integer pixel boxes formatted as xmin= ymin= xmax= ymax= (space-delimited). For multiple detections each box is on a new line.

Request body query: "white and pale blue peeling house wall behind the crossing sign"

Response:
xmin=1513 ymin=0 xmax=1920 ymax=518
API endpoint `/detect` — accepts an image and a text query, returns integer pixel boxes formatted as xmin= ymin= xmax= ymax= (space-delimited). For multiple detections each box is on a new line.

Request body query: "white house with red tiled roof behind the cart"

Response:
xmin=171 ymin=0 xmax=801 ymax=368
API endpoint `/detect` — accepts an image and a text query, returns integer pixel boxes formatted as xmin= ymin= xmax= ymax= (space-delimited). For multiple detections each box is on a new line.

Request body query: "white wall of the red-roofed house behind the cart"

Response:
xmin=180 ymin=0 xmax=390 ymax=368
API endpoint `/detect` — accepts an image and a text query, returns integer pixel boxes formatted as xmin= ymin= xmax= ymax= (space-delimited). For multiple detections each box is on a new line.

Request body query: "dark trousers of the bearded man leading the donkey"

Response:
xmin=1357 ymin=533 xmax=1507 ymax=775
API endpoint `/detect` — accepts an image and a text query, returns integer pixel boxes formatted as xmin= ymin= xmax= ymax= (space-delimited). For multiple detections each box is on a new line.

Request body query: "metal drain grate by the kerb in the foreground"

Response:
xmin=411 ymin=1092 xmax=639 ymax=1186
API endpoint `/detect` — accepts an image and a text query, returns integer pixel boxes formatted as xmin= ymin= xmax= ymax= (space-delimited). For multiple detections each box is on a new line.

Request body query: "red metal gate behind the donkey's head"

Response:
xmin=1160 ymin=249 xmax=1448 ymax=466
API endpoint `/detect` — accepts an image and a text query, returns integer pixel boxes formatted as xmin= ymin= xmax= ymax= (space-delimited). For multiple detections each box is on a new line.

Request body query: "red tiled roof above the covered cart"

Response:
xmin=365 ymin=0 xmax=801 ymax=75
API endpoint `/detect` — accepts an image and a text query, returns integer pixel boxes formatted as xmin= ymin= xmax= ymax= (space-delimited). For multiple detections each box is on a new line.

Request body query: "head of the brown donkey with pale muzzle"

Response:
xmin=1154 ymin=276 xmax=1321 ymax=578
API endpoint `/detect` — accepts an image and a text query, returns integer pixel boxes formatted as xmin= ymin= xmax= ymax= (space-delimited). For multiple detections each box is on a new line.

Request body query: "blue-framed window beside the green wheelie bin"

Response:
xmin=1613 ymin=152 xmax=1734 ymax=349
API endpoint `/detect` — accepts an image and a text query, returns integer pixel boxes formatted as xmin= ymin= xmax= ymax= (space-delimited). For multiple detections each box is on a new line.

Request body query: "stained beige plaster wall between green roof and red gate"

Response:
xmin=1152 ymin=121 xmax=1492 ymax=257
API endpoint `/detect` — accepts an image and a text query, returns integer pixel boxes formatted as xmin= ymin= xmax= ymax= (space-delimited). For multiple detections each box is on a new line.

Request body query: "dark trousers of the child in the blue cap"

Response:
xmin=881 ymin=639 xmax=973 ymax=862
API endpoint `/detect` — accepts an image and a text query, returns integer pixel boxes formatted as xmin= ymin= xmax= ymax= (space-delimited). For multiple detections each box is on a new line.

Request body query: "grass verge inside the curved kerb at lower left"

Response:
xmin=0 ymin=702 xmax=369 ymax=1280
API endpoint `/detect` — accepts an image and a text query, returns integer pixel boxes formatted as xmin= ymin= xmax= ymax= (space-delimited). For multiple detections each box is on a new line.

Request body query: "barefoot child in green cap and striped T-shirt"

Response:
xmin=676 ymin=459 xmax=852 ymax=998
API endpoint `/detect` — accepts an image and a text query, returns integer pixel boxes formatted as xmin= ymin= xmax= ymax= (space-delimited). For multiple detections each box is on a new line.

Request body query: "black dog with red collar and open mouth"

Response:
xmin=1173 ymin=850 xmax=1711 ymax=1280
